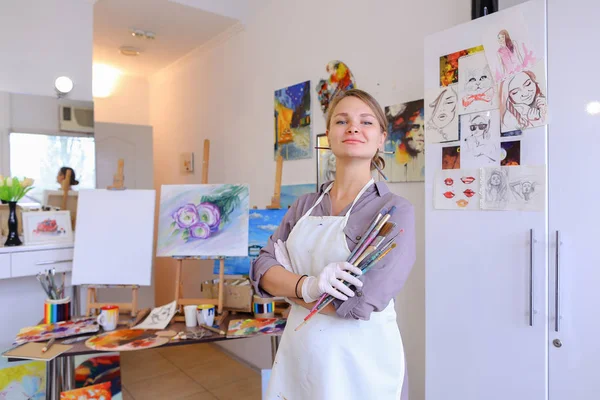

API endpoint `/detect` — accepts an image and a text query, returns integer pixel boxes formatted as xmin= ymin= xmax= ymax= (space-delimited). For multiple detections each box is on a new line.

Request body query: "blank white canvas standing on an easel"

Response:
xmin=72 ymin=189 xmax=156 ymax=286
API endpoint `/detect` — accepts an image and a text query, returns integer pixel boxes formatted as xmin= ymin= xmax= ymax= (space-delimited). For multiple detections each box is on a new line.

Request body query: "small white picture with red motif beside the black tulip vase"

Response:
xmin=23 ymin=211 xmax=73 ymax=244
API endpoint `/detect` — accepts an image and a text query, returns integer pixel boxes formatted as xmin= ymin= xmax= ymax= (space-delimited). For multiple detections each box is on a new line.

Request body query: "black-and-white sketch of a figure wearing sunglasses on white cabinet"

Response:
xmin=460 ymin=110 xmax=500 ymax=168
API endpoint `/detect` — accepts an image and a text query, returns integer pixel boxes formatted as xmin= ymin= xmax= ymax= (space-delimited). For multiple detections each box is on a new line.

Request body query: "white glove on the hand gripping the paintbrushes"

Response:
xmin=302 ymin=262 xmax=363 ymax=303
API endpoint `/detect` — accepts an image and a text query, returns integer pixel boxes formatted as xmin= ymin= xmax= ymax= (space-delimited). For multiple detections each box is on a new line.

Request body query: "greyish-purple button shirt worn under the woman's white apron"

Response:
xmin=250 ymin=182 xmax=416 ymax=320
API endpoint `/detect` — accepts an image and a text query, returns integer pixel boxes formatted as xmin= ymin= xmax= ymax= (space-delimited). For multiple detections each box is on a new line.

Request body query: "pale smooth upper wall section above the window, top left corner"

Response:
xmin=0 ymin=0 xmax=93 ymax=100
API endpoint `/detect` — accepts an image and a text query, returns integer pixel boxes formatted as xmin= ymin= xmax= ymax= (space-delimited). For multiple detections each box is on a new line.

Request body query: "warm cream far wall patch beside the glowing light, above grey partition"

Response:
xmin=94 ymin=75 xmax=150 ymax=125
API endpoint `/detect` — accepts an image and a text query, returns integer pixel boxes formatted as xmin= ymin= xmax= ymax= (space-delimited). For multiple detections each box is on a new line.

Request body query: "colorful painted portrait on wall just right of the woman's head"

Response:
xmin=384 ymin=99 xmax=425 ymax=182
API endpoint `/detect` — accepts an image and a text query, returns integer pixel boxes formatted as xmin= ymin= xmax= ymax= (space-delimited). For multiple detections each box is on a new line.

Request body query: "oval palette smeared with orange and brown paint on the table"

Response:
xmin=85 ymin=329 xmax=169 ymax=351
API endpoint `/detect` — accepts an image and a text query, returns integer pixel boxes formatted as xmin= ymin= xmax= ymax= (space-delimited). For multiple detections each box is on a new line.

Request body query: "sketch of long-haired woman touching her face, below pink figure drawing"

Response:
xmin=500 ymin=62 xmax=548 ymax=132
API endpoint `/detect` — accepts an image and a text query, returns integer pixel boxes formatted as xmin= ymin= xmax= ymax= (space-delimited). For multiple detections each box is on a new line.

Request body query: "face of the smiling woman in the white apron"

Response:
xmin=327 ymin=97 xmax=386 ymax=160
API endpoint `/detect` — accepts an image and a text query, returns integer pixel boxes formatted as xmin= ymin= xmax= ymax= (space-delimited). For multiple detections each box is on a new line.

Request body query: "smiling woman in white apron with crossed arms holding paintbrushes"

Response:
xmin=250 ymin=89 xmax=415 ymax=400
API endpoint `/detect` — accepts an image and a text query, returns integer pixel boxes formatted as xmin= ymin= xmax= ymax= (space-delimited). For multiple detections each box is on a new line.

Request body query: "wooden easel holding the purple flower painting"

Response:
xmin=174 ymin=139 xmax=227 ymax=322
